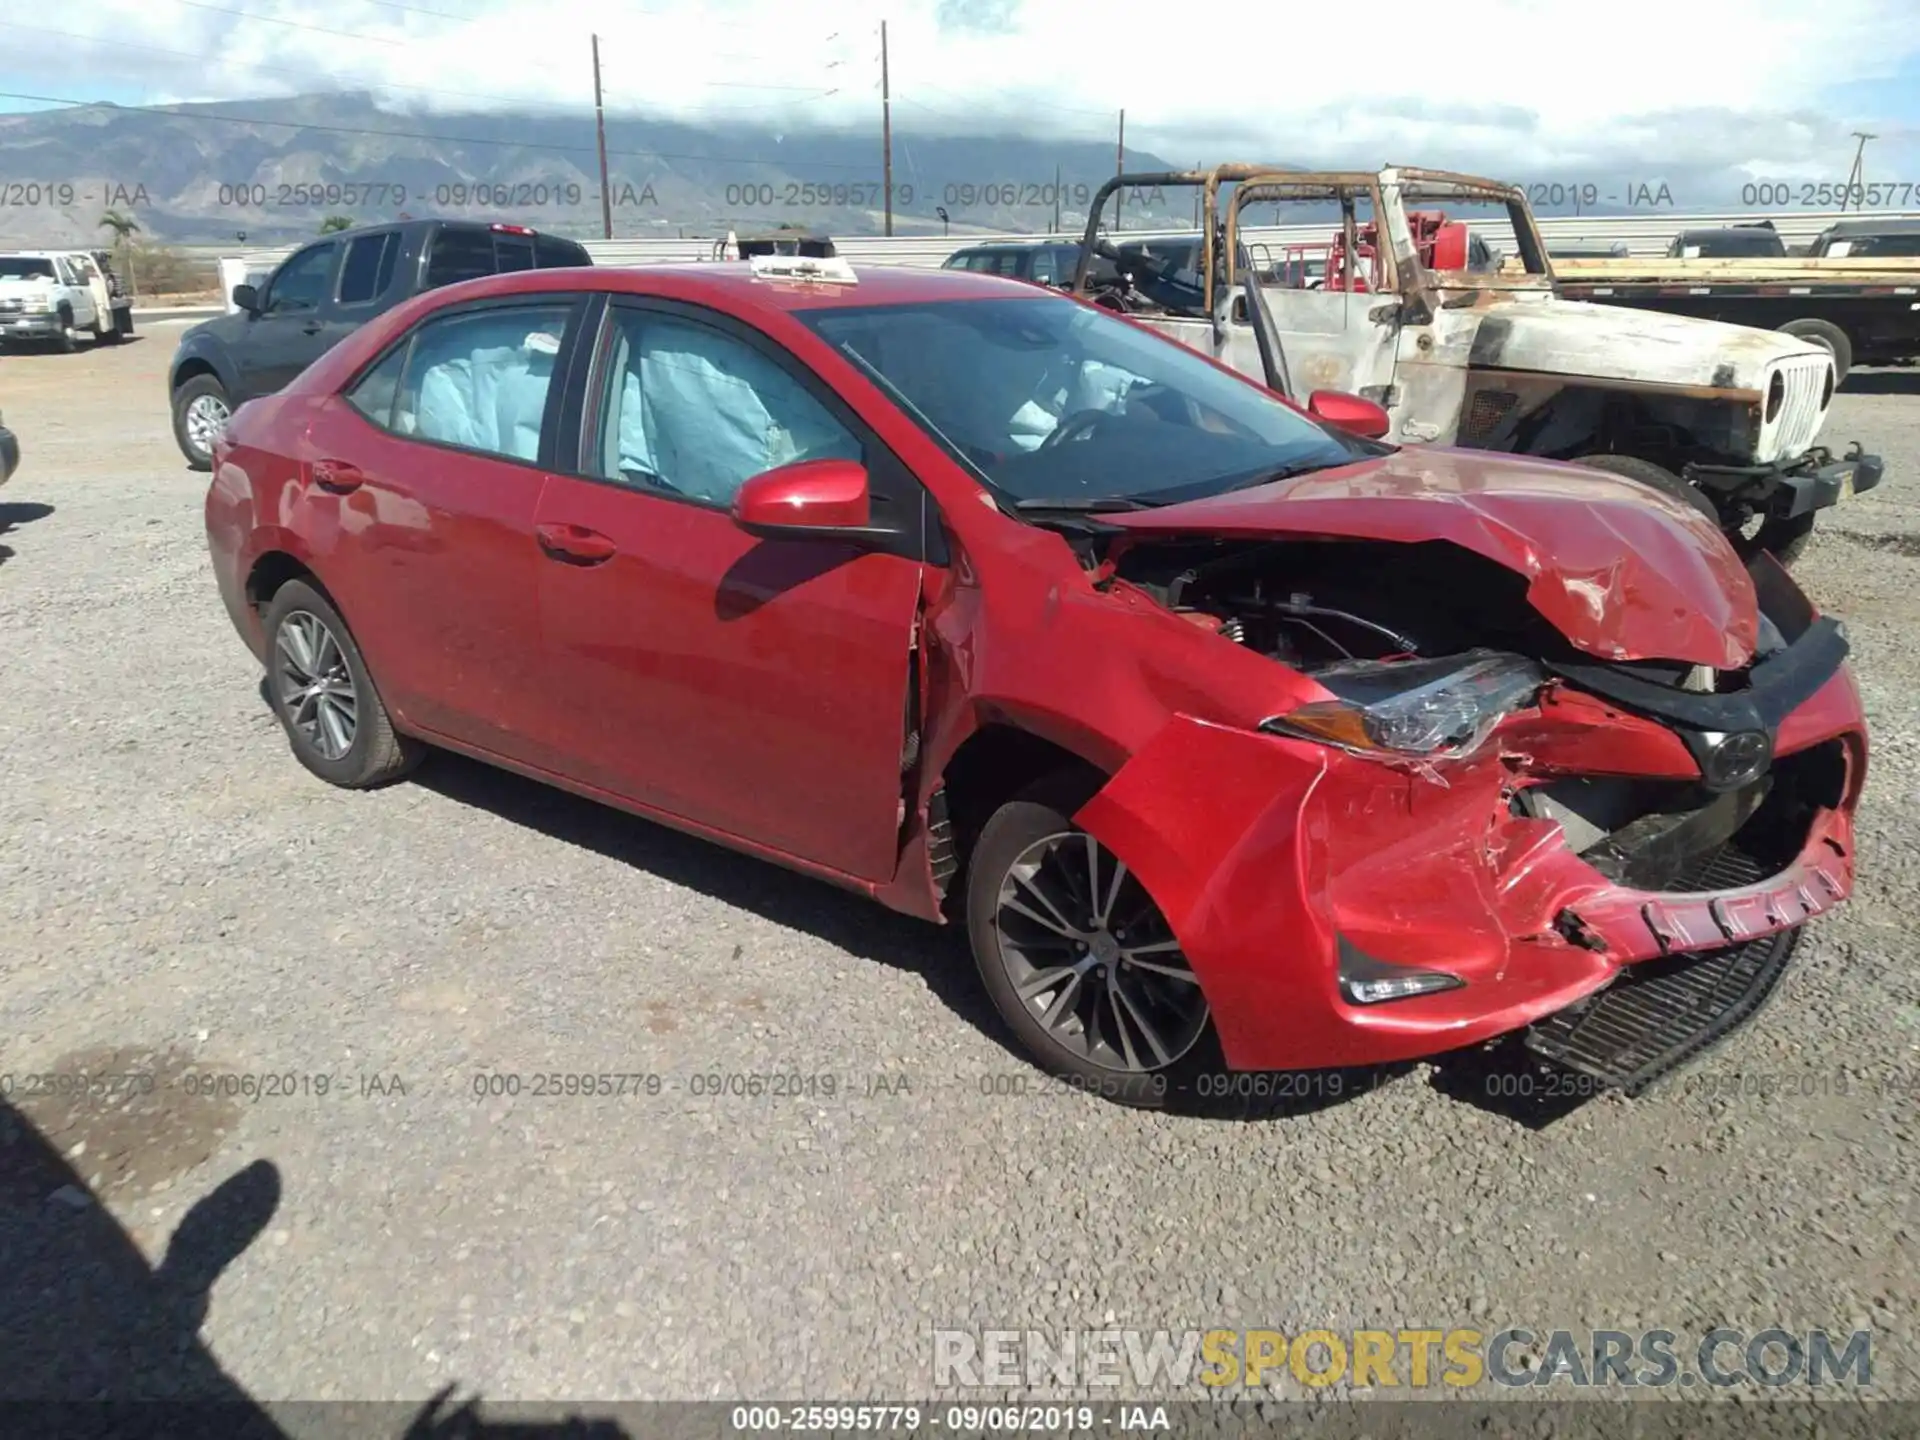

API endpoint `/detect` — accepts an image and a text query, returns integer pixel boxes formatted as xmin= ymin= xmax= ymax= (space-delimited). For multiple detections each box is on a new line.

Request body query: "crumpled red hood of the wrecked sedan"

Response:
xmin=1100 ymin=445 xmax=1759 ymax=670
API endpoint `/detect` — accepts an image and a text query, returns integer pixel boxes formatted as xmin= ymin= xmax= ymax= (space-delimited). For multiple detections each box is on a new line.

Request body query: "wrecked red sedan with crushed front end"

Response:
xmin=205 ymin=259 xmax=1866 ymax=1104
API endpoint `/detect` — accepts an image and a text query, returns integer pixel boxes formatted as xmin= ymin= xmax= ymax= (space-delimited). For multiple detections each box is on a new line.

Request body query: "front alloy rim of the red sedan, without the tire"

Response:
xmin=993 ymin=829 xmax=1208 ymax=1073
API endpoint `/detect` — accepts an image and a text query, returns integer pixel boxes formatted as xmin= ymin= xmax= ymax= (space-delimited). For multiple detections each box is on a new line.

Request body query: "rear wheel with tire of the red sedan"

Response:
xmin=265 ymin=580 xmax=424 ymax=789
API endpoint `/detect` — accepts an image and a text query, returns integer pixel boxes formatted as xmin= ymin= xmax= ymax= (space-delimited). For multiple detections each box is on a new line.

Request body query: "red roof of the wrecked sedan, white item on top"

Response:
xmin=416 ymin=261 xmax=1046 ymax=313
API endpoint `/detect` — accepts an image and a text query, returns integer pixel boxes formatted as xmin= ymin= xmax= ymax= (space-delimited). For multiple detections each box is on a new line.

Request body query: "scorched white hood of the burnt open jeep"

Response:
xmin=1442 ymin=294 xmax=1826 ymax=390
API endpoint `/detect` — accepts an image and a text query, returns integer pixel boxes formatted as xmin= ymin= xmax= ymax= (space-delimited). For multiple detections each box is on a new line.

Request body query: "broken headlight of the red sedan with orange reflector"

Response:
xmin=1261 ymin=651 xmax=1548 ymax=760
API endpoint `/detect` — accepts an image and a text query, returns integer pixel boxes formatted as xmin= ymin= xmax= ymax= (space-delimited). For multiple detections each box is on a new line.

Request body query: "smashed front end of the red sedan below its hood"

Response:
xmin=1077 ymin=518 xmax=1866 ymax=1091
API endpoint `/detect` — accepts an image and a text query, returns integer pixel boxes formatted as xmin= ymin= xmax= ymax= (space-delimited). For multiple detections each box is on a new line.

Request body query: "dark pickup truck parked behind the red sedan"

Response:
xmin=167 ymin=221 xmax=593 ymax=470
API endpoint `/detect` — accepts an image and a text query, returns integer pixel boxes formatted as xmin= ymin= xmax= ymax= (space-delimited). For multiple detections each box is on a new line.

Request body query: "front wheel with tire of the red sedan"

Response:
xmin=966 ymin=780 xmax=1221 ymax=1110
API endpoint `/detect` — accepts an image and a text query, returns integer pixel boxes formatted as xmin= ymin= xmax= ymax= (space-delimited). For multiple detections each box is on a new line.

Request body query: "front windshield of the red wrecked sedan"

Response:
xmin=799 ymin=296 xmax=1386 ymax=505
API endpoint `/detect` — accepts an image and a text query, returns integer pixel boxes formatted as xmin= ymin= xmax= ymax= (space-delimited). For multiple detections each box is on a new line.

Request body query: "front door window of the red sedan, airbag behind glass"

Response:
xmin=595 ymin=309 xmax=862 ymax=505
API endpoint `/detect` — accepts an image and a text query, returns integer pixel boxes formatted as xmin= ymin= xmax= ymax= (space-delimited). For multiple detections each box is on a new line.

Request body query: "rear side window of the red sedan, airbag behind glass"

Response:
xmin=348 ymin=303 xmax=572 ymax=463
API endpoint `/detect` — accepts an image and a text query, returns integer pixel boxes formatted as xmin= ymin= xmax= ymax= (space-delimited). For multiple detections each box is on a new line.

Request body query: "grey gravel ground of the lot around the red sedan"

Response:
xmin=0 ymin=326 xmax=1920 ymax=1428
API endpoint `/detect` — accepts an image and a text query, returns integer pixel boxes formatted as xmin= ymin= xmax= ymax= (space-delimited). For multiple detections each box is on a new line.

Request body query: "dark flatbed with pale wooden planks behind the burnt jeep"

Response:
xmin=1553 ymin=255 xmax=1920 ymax=378
